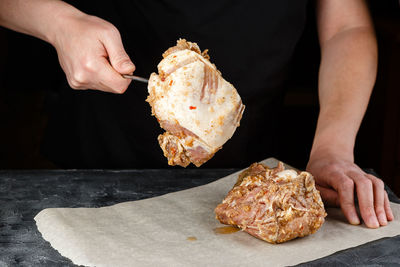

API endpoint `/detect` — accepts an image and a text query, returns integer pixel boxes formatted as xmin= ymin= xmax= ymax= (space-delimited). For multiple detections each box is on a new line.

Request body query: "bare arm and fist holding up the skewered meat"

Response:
xmin=0 ymin=0 xmax=135 ymax=93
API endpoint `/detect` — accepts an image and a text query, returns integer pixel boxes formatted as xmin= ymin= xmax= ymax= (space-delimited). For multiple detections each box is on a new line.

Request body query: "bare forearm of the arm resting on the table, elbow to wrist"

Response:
xmin=311 ymin=26 xmax=377 ymax=160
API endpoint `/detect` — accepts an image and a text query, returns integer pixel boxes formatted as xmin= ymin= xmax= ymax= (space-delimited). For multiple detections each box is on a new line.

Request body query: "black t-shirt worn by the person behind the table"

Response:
xmin=43 ymin=0 xmax=307 ymax=168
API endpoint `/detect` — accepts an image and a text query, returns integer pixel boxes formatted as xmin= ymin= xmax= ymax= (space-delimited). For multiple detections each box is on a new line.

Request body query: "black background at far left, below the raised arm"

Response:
xmin=0 ymin=28 xmax=64 ymax=168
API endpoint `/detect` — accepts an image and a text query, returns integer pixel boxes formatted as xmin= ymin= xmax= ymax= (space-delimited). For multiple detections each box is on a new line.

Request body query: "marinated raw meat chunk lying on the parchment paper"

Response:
xmin=215 ymin=162 xmax=326 ymax=243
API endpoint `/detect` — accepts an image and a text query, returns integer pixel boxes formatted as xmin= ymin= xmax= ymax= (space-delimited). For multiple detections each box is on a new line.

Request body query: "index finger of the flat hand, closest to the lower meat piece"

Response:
xmin=335 ymin=174 xmax=360 ymax=224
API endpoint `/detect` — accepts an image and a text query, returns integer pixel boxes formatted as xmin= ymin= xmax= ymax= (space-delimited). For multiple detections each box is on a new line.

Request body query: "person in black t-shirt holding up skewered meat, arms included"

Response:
xmin=0 ymin=0 xmax=393 ymax=228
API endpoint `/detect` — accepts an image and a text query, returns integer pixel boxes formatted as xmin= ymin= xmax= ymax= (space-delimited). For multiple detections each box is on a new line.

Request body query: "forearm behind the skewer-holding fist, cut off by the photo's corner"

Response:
xmin=0 ymin=0 xmax=83 ymax=43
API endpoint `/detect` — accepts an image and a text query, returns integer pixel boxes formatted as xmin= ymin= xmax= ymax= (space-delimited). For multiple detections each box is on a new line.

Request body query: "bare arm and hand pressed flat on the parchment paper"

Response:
xmin=307 ymin=0 xmax=393 ymax=228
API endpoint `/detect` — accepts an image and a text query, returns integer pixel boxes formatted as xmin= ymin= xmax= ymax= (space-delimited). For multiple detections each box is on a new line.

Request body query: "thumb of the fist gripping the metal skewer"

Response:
xmin=102 ymin=28 xmax=135 ymax=74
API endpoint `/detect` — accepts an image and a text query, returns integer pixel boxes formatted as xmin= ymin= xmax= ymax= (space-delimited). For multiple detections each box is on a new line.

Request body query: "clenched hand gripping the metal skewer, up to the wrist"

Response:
xmin=52 ymin=14 xmax=135 ymax=94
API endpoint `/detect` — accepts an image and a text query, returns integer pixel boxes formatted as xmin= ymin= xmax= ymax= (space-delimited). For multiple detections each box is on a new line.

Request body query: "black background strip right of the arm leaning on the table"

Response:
xmin=366 ymin=0 xmax=400 ymax=195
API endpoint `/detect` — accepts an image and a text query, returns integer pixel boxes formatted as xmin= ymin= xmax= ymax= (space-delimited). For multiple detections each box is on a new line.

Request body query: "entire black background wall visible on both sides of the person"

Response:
xmin=0 ymin=0 xmax=400 ymax=195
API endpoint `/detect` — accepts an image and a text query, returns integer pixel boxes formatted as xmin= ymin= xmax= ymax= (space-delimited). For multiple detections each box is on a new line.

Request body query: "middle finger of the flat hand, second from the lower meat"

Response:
xmin=349 ymin=172 xmax=379 ymax=228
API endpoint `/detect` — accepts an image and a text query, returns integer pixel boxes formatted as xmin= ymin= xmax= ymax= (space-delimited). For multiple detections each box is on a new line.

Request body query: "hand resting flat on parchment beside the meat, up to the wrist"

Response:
xmin=307 ymin=151 xmax=394 ymax=228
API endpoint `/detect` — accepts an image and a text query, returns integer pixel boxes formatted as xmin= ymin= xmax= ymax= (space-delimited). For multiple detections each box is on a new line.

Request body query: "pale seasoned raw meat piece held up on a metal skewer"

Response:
xmin=147 ymin=39 xmax=244 ymax=167
